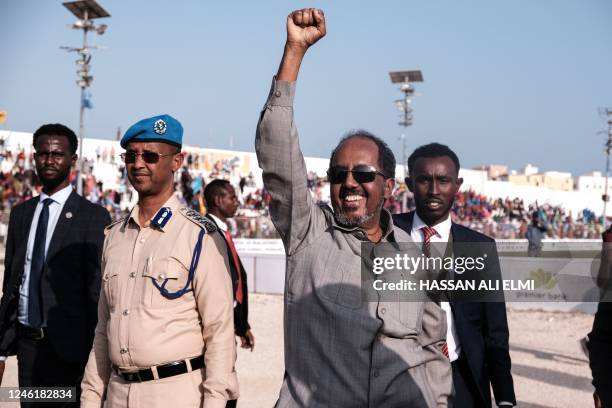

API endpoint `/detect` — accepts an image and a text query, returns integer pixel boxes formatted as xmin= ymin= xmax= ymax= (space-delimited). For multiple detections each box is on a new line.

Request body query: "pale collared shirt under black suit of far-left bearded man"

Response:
xmin=17 ymin=185 xmax=72 ymax=326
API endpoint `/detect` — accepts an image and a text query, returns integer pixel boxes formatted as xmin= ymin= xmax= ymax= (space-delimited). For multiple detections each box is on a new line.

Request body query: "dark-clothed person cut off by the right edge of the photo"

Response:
xmin=587 ymin=227 xmax=612 ymax=408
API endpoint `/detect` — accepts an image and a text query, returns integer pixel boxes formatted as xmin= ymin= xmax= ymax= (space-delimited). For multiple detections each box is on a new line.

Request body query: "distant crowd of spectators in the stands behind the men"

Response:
xmin=0 ymin=139 xmax=603 ymax=244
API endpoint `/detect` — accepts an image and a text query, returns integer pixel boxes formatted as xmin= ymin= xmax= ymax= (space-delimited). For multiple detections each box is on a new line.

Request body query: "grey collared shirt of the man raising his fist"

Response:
xmin=255 ymin=81 xmax=451 ymax=408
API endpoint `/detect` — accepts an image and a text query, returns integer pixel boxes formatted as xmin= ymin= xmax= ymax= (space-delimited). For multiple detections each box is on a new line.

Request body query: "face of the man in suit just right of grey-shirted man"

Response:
xmin=406 ymin=156 xmax=463 ymax=227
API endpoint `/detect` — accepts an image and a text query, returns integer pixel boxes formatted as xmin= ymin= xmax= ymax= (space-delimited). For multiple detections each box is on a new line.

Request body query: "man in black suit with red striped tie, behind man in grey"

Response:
xmin=393 ymin=143 xmax=516 ymax=408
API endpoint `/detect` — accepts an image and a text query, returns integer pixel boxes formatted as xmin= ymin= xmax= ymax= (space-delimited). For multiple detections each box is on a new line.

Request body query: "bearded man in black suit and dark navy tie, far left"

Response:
xmin=0 ymin=124 xmax=110 ymax=406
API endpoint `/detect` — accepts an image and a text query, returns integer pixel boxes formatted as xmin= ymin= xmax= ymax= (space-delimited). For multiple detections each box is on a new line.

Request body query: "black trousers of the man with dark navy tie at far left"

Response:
xmin=17 ymin=338 xmax=86 ymax=408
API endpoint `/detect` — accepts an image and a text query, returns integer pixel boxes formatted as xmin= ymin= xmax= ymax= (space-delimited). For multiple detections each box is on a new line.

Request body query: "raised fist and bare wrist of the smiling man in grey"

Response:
xmin=276 ymin=8 xmax=327 ymax=81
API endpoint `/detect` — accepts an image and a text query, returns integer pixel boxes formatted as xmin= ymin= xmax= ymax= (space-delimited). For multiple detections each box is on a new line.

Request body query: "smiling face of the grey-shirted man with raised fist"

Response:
xmin=330 ymin=137 xmax=395 ymax=241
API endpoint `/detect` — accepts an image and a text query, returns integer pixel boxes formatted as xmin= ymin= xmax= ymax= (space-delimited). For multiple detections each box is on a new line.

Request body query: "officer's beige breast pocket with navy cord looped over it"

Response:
xmin=142 ymin=258 xmax=192 ymax=307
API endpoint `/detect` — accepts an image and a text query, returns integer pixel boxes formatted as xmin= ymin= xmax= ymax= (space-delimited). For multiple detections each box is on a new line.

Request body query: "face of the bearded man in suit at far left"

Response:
xmin=34 ymin=135 xmax=77 ymax=195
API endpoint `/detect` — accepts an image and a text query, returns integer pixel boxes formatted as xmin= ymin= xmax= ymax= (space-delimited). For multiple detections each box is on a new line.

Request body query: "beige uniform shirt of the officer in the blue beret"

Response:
xmin=81 ymin=196 xmax=238 ymax=407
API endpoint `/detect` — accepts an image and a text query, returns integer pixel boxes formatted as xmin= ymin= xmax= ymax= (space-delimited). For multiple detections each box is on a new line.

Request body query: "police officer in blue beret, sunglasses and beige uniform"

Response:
xmin=81 ymin=115 xmax=238 ymax=408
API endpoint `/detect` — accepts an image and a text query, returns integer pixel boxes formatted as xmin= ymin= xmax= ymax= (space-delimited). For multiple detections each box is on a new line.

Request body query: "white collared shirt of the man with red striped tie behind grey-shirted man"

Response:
xmin=410 ymin=211 xmax=461 ymax=361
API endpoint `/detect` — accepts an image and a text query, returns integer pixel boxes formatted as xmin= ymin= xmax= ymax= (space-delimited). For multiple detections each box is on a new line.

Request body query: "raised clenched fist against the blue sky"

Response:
xmin=287 ymin=8 xmax=326 ymax=49
